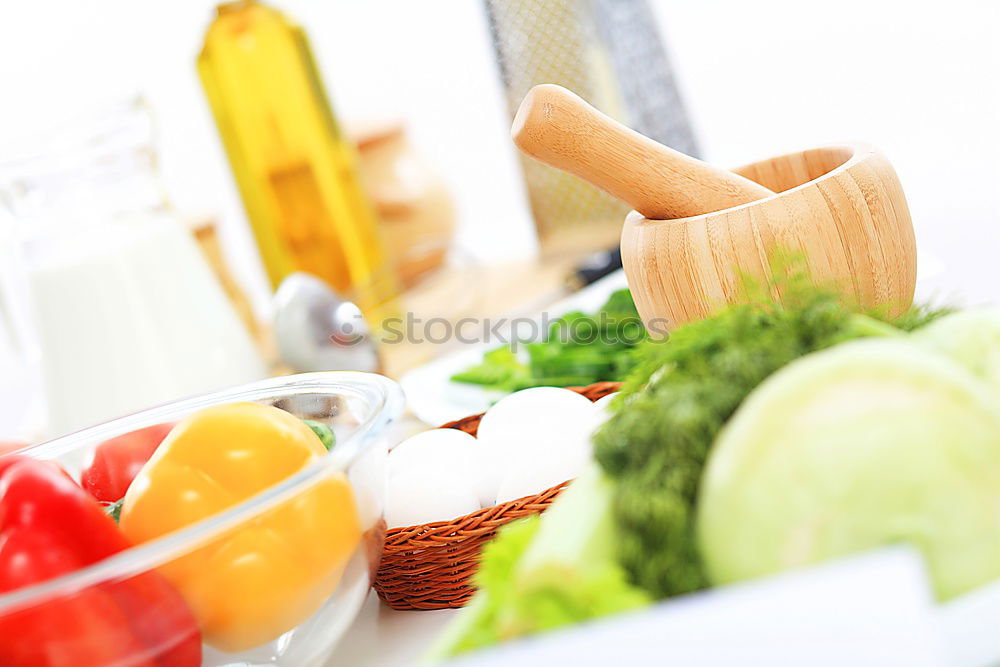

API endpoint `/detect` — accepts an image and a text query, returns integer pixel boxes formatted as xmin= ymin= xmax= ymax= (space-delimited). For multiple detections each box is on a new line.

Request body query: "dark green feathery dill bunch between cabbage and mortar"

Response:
xmin=594 ymin=260 xmax=939 ymax=598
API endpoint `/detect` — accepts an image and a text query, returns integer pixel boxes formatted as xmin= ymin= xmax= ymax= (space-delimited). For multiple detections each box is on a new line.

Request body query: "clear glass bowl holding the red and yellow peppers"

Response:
xmin=0 ymin=372 xmax=404 ymax=667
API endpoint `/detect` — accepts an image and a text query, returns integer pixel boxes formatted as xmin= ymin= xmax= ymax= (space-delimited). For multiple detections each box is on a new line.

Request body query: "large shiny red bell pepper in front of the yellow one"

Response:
xmin=0 ymin=454 xmax=201 ymax=667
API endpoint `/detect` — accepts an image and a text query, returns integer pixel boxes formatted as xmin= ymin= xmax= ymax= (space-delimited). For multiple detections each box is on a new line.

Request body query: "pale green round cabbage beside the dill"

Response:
xmin=697 ymin=340 xmax=1000 ymax=600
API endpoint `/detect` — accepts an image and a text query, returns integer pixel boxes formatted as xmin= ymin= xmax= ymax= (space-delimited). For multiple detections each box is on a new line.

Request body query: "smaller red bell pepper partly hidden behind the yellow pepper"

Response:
xmin=80 ymin=424 xmax=173 ymax=503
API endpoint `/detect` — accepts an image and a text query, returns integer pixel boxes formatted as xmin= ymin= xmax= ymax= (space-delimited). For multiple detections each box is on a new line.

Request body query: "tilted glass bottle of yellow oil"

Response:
xmin=198 ymin=0 xmax=396 ymax=324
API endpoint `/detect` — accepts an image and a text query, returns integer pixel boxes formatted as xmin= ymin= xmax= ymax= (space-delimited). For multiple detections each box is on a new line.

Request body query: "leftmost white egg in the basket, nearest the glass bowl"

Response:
xmin=385 ymin=464 xmax=479 ymax=528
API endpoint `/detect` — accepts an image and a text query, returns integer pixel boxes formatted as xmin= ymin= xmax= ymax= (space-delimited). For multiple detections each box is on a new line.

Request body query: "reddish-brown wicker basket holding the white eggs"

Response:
xmin=375 ymin=382 xmax=620 ymax=609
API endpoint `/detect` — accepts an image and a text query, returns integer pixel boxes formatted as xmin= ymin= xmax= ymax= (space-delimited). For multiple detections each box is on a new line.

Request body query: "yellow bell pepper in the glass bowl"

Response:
xmin=120 ymin=403 xmax=362 ymax=651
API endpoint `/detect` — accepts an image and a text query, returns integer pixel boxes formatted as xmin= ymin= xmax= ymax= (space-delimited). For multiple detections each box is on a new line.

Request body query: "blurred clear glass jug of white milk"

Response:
xmin=0 ymin=99 xmax=265 ymax=435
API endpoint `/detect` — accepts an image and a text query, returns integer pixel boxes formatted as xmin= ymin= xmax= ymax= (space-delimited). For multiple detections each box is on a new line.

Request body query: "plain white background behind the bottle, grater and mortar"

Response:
xmin=0 ymin=0 xmax=1000 ymax=314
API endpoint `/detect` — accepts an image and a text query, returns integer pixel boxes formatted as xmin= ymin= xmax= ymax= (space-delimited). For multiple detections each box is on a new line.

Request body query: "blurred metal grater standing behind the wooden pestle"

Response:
xmin=484 ymin=0 xmax=698 ymax=242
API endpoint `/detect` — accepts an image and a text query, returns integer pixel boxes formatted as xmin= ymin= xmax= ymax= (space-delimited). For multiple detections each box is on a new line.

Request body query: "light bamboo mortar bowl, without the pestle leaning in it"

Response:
xmin=621 ymin=144 xmax=917 ymax=335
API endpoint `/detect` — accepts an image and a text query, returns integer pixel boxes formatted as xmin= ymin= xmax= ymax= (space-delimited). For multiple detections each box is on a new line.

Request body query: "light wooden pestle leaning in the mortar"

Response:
xmin=511 ymin=84 xmax=774 ymax=220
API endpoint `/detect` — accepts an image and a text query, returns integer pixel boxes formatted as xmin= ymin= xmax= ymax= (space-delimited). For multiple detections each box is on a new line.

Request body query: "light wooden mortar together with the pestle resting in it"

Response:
xmin=511 ymin=84 xmax=917 ymax=335
